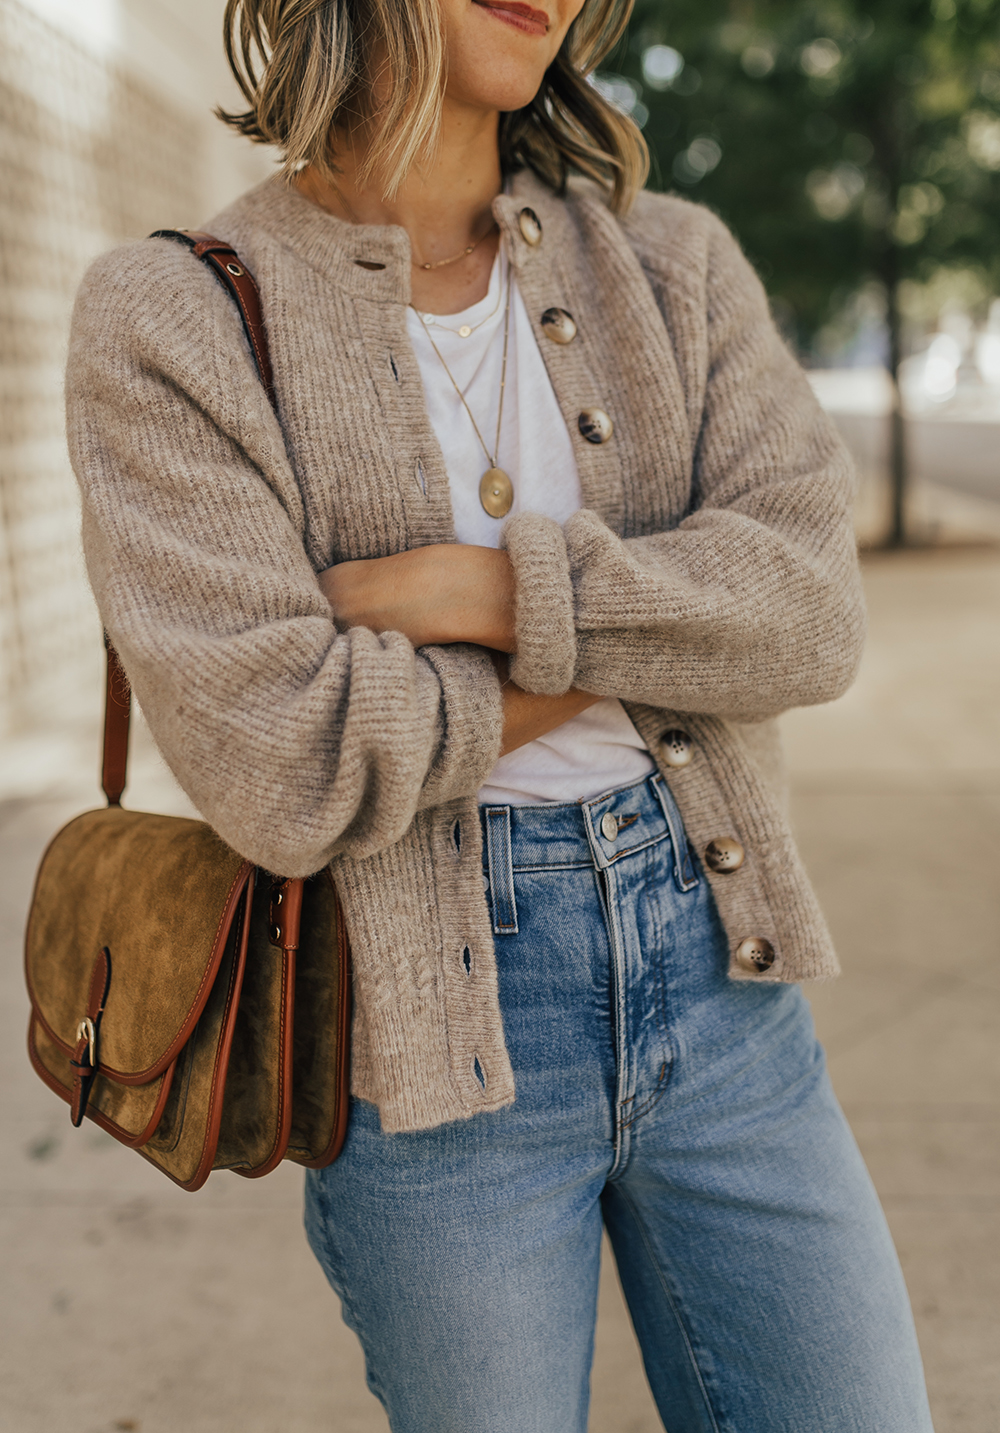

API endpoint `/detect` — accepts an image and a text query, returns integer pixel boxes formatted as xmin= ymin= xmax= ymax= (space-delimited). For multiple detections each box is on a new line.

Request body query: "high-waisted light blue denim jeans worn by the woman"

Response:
xmin=307 ymin=777 xmax=931 ymax=1433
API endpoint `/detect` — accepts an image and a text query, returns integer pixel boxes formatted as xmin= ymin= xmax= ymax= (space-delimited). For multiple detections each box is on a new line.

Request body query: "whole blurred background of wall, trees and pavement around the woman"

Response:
xmin=0 ymin=0 xmax=1000 ymax=1433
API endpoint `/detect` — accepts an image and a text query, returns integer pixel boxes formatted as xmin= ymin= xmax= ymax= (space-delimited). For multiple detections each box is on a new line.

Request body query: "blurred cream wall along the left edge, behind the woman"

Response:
xmin=0 ymin=0 xmax=265 ymax=737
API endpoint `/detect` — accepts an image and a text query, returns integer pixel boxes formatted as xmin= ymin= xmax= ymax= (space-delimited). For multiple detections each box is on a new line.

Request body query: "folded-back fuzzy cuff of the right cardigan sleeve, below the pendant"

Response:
xmin=500 ymin=513 xmax=576 ymax=696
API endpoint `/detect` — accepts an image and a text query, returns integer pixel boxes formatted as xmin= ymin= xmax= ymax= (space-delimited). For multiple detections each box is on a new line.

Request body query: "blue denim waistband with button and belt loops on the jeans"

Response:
xmin=480 ymin=772 xmax=698 ymax=934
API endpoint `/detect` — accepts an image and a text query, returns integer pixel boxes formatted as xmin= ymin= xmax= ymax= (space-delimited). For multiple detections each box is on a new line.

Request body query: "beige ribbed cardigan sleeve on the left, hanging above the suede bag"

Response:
xmin=67 ymin=244 xmax=501 ymax=876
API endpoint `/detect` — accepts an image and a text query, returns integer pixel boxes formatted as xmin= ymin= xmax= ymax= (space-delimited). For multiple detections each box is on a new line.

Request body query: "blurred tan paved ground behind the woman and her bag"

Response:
xmin=0 ymin=552 xmax=1000 ymax=1433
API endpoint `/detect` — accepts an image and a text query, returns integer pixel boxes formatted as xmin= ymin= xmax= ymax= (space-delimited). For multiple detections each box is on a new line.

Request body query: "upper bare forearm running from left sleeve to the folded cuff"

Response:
xmin=319 ymin=543 xmax=514 ymax=652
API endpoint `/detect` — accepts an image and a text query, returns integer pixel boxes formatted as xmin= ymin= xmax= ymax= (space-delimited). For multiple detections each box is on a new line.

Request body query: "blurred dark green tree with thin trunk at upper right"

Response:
xmin=603 ymin=0 xmax=1000 ymax=543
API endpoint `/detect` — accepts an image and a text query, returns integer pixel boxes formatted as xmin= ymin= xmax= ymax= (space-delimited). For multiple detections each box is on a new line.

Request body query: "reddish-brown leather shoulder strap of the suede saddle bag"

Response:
xmin=102 ymin=229 xmax=278 ymax=805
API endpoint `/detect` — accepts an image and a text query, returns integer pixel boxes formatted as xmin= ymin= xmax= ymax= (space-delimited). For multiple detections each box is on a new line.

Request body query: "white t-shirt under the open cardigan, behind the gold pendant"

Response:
xmin=407 ymin=252 xmax=653 ymax=805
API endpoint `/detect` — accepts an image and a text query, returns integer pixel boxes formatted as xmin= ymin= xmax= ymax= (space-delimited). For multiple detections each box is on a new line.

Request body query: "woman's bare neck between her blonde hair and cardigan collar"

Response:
xmin=295 ymin=97 xmax=503 ymax=314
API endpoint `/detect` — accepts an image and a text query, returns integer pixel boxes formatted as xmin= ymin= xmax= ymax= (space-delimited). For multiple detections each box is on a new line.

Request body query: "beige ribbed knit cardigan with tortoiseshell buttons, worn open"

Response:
xmin=67 ymin=173 xmax=864 ymax=1131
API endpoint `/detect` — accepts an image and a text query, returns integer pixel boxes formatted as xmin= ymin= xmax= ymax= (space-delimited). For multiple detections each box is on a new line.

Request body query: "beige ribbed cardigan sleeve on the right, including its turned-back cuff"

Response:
xmin=507 ymin=211 xmax=865 ymax=721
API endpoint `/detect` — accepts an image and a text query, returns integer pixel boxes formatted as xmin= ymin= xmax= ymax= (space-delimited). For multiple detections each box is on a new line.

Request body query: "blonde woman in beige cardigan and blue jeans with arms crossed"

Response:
xmin=69 ymin=0 xmax=930 ymax=1433
